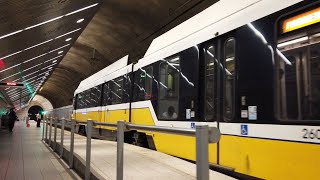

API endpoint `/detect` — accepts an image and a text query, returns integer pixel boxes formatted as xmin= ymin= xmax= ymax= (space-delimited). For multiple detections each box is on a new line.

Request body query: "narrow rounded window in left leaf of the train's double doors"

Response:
xmin=204 ymin=46 xmax=217 ymax=121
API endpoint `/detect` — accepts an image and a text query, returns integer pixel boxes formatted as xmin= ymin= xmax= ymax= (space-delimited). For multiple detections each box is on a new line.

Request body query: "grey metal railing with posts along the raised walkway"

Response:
xmin=42 ymin=118 xmax=220 ymax=180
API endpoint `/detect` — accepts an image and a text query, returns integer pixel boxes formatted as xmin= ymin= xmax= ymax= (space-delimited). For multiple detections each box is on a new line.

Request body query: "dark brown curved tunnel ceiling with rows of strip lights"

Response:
xmin=0 ymin=0 xmax=217 ymax=108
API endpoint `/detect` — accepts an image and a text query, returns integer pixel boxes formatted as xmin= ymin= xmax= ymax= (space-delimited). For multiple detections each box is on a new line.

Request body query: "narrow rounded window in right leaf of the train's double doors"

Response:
xmin=223 ymin=38 xmax=236 ymax=121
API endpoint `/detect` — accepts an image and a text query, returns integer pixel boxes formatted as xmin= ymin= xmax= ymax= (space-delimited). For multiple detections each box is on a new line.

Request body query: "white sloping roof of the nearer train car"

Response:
xmin=135 ymin=0 xmax=302 ymax=69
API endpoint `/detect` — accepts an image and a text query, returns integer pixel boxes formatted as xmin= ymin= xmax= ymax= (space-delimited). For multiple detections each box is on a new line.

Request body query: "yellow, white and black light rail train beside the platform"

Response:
xmin=51 ymin=0 xmax=320 ymax=179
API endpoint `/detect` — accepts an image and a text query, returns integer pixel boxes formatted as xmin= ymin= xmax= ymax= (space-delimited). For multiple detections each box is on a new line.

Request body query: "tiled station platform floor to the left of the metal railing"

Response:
xmin=0 ymin=121 xmax=81 ymax=180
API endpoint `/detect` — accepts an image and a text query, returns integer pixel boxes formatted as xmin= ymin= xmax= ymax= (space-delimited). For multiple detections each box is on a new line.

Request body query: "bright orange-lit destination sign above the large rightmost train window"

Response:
xmin=282 ymin=8 xmax=320 ymax=33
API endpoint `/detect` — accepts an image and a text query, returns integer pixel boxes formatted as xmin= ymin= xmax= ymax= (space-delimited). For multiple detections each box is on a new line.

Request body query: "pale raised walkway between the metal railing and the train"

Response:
xmin=48 ymin=123 xmax=234 ymax=180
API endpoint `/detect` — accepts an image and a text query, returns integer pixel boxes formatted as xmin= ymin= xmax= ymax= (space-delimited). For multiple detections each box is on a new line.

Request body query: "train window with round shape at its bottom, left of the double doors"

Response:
xmin=158 ymin=56 xmax=180 ymax=120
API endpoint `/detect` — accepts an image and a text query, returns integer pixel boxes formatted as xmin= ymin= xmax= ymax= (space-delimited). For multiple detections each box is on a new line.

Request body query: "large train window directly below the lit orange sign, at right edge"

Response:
xmin=278 ymin=31 xmax=320 ymax=120
